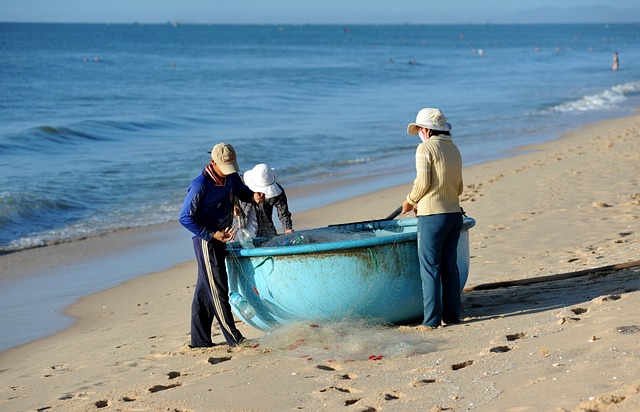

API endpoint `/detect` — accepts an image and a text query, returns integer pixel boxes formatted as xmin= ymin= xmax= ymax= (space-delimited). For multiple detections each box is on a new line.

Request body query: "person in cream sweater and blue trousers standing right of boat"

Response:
xmin=402 ymin=108 xmax=463 ymax=330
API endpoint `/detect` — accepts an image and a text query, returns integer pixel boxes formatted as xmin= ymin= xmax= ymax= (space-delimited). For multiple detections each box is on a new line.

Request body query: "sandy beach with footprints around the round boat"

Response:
xmin=0 ymin=115 xmax=640 ymax=412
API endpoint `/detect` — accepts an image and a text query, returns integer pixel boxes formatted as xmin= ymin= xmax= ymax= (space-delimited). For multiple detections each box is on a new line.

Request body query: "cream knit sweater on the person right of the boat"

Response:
xmin=407 ymin=135 xmax=463 ymax=216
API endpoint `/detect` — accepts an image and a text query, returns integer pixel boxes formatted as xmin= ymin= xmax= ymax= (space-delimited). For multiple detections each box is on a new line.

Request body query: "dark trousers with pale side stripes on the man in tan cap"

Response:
xmin=191 ymin=236 xmax=244 ymax=347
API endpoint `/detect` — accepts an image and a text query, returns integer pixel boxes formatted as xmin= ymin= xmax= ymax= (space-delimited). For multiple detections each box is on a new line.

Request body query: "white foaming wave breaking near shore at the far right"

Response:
xmin=547 ymin=82 xmax=640 ymax=113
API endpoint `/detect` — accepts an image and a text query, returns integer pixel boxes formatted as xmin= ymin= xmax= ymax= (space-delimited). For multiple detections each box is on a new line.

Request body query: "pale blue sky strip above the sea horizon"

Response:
xmin=0 ymin=0 xmax=640 ymax=24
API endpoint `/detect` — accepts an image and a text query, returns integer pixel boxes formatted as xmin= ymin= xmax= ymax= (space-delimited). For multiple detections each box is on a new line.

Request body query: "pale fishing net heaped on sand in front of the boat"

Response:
xmin=260 ymin=319 xmax=436 ymax=361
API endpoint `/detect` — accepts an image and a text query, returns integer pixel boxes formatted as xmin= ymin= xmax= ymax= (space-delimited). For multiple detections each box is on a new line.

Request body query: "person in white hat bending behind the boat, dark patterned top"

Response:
xmin=233 ymin=163 xmax=293 ymax=238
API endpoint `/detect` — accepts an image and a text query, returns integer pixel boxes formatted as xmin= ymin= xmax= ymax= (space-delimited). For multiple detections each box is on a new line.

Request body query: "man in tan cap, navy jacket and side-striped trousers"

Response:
xmin=180 ymin=143 xmax=264 ymax=348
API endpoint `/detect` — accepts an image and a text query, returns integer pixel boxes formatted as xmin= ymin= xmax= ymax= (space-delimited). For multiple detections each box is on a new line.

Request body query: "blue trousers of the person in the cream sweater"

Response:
xmin=418 ymin=213 xmax=462 ymax=326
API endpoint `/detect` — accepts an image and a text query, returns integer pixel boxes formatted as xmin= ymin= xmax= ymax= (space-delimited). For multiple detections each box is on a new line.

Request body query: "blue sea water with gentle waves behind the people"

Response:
xmin=0 ymin=23 xmax=640 ymax=350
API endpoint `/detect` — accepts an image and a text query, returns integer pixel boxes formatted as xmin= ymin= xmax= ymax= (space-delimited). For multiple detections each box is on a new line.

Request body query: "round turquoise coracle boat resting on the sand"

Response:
xmin=226 ymin=217 xmax=475 ymax=330
